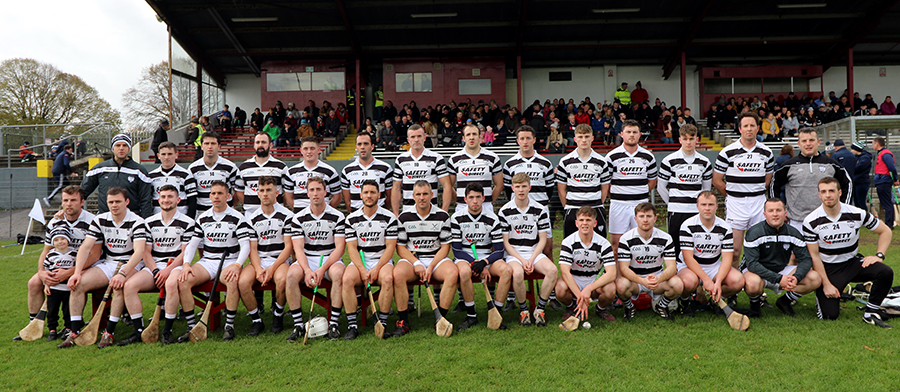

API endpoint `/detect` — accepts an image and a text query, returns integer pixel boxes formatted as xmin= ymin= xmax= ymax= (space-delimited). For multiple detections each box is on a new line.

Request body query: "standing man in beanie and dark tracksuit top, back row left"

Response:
xmin=81 ymin=133 xmax=153 ymax=218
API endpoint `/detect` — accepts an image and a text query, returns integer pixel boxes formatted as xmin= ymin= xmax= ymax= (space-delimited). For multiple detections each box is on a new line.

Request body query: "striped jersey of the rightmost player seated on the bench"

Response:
xmin=497 ymin=199 xmax=550 ymax=256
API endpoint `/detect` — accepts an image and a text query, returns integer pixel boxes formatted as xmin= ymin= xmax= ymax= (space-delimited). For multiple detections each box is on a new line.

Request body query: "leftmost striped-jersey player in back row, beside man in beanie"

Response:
xmin=148 ymin=142 xmax=197 ymax=216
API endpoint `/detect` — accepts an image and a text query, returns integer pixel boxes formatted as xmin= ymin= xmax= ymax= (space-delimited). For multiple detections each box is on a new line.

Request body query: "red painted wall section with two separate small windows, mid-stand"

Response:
xmin=375 ymin=58 xmax=506 ymax=108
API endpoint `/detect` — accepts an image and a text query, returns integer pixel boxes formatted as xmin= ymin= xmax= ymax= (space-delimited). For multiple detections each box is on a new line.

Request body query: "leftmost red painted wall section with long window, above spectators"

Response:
xmin=260 ymin=60 xmax=353 ymax=113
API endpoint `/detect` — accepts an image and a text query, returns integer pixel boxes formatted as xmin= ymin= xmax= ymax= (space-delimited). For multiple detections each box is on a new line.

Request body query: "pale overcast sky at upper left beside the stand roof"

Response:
xmin=0 ymin=0 xmax=168 ymax=110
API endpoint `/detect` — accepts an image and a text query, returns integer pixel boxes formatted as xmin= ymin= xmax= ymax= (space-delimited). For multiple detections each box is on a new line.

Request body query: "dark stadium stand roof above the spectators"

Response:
xmin=147 ymin=0 xmax=900 ymax=82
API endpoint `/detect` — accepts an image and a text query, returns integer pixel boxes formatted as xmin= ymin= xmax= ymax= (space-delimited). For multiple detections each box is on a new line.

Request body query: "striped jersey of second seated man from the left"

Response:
xmin=86 ymin=210 xmax=147 ymax=263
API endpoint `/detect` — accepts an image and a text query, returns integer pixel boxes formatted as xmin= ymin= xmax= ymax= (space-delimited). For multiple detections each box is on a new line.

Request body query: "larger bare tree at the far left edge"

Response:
xmin=0 ymin=59 xmax=119 ymax=125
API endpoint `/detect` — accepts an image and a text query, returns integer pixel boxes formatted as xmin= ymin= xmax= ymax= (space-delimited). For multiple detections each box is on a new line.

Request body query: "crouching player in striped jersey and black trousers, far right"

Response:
xmin=803 ymin=177 xmax=894 ymax=328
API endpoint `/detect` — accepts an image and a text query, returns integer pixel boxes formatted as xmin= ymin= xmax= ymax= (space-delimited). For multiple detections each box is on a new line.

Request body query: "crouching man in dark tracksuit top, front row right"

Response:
xmin=741 ymin=199 xmax=822 ymax=317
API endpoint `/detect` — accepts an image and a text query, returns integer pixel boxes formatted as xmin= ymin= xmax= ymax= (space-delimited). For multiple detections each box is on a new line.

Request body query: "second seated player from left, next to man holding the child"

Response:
xmin=60 ymin=187 xmax=147 ymax=348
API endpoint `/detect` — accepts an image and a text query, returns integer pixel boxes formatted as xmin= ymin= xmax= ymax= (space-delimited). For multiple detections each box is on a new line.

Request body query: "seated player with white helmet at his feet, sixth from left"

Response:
xmin=286 ymin=177 xmax=349 ymax=341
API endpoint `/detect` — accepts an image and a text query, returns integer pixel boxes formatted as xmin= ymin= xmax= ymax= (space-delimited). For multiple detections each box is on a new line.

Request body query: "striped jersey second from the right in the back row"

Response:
xmin=658 ymin=150 xmax=713 ymax=214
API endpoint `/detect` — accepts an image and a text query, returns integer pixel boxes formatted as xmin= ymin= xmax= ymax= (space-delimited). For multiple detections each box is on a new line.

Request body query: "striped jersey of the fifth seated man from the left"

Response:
xmin=246 ymin=204 xmax=294 ymax=262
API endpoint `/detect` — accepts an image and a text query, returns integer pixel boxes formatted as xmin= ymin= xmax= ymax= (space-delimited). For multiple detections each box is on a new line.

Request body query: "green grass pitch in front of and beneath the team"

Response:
xmin=0 ymin=230 xmax=900 ymax=390
